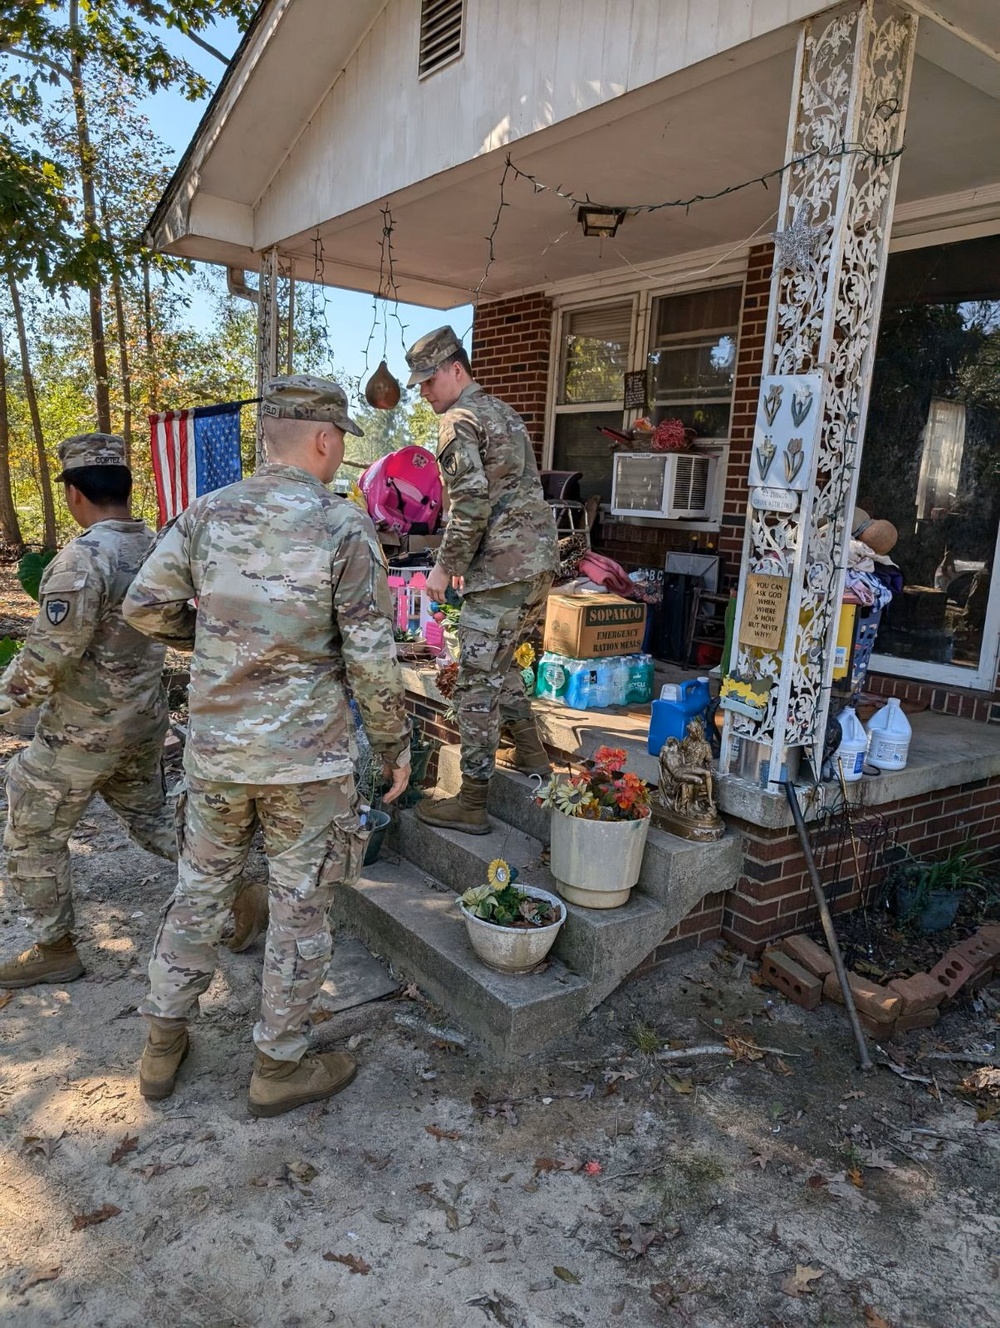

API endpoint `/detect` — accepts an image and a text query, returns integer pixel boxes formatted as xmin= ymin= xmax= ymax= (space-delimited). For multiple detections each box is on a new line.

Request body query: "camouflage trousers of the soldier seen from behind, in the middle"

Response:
xmin=141 ymin=776 xmax=368 ymax=1061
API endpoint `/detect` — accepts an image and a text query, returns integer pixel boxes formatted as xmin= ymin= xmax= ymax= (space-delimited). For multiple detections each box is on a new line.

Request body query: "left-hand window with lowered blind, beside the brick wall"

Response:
xmin=552 ymin=300 xmax=632 ymax=502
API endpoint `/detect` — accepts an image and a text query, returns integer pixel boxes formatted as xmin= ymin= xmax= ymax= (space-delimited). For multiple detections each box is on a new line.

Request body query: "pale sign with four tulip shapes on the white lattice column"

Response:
xmin=749 ymin=373 xmax=823 ymax=496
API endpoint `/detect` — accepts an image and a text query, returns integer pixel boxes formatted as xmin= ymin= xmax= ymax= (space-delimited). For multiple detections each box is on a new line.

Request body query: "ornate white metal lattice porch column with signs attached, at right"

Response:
xmin=722 ymin=0 xmax=916 ymax=785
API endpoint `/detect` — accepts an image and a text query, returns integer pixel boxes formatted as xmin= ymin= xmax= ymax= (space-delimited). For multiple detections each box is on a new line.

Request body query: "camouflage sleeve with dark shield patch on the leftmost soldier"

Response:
xmin=0 ymin=544 xmax=108 ymax=706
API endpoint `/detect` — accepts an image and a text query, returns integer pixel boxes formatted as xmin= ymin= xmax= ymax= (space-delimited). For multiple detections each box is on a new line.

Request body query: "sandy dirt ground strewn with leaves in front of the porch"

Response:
xmin=0 ymin=571 xmax=1000 ymax=1328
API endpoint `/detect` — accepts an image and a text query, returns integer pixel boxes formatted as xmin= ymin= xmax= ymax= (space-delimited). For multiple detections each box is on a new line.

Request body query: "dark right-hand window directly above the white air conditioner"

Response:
xmin=647 ymin=286 xmax=742 ymax=440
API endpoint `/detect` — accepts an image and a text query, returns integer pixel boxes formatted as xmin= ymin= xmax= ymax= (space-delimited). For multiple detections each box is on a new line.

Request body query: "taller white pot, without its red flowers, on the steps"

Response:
xmin=548 ymin=809 xmax=649 ymax=908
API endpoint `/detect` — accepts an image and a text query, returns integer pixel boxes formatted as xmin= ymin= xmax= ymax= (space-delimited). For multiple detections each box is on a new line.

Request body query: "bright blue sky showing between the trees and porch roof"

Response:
xmin=143 ymin=20 xmax=471 ymax=377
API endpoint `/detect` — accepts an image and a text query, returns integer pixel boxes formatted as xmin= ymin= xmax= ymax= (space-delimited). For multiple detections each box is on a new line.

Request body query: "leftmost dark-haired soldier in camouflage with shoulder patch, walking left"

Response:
xmin=0 ymin=433 xmax=177 ymax=987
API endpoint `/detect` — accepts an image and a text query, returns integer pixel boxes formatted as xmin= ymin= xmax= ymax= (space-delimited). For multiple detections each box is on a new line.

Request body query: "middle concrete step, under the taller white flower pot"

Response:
xmin=392 ymin=811 xmax=683 ymax=1005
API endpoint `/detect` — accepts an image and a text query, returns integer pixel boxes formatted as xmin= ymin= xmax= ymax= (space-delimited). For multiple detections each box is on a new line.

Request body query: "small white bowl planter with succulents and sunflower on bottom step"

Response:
xmin=457 ymin=858 xmax=566 ymax=973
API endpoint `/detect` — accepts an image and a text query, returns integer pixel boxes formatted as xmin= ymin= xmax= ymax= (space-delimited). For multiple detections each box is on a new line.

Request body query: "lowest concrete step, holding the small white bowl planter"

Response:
xmin=333 ymin=862 xmax=592 ymax=1060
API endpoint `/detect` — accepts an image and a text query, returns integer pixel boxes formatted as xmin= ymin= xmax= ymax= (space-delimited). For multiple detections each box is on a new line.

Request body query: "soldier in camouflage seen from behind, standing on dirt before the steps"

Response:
xmin=125 ymin=376 xmax=409 ymax=1116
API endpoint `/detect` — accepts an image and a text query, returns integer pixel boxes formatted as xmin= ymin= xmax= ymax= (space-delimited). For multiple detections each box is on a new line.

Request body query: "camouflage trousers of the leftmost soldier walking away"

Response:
xmin=4 ymin=724 xmax=177 ymax=944
